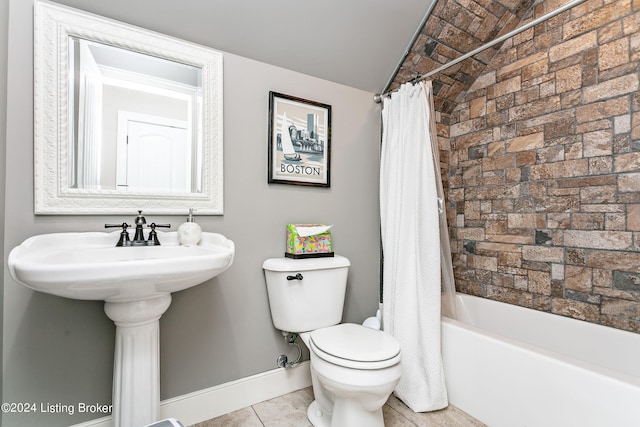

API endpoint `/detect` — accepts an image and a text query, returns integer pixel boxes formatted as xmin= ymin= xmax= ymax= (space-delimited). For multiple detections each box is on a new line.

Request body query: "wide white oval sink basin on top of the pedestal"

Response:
xmin=8 ymin=231 xmax=235 ymax=302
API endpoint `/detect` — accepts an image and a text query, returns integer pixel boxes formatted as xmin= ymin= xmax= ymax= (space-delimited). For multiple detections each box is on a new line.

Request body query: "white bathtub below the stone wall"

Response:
xmin=442 ymin=294 xmax=640 ymax=427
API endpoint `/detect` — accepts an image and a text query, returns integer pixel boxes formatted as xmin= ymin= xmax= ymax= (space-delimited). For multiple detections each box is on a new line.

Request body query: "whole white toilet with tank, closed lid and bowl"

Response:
xmin=262 ymin=255 xmax=401 ymax=427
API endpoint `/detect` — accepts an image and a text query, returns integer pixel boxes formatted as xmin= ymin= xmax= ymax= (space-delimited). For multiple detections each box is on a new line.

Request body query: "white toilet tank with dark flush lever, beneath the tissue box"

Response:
xmin=262 ymin=255 xmax=351 ymax=332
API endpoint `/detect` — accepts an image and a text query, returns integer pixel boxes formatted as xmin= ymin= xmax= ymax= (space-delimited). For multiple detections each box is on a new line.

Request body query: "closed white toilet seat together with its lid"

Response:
xmin=309 ymin=323 xmax=400 ymax=369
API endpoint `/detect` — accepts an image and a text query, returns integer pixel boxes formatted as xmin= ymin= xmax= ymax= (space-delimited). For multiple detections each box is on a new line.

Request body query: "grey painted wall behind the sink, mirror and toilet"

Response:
xmin=0 ymin=0 xmax=380 ymax=427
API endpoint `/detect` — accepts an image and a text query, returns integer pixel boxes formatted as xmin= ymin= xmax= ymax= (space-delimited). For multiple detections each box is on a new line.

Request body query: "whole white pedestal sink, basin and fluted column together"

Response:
xmin=8 ymin=231 xmax=235 ymax=427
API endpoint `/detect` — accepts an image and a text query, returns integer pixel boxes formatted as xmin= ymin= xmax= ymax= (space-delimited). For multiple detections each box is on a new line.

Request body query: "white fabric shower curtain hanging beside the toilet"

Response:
xmin=380 ymin=82 xmax=448 ymax=412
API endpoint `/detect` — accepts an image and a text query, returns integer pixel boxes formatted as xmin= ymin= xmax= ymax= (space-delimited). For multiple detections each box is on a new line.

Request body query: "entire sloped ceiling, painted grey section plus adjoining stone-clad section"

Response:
xmin=55 ymin=0 xmax=544 ymax=102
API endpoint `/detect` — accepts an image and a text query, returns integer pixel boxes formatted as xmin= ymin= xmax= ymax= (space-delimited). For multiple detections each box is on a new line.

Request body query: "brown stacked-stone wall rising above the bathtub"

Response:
xmin=438 ymin=0 xmax=640 ymax=332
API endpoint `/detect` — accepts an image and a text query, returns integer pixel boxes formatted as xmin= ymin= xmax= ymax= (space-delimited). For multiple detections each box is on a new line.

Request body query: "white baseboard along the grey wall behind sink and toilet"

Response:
xmin=71 ymin=361 xmax=311 ymax=427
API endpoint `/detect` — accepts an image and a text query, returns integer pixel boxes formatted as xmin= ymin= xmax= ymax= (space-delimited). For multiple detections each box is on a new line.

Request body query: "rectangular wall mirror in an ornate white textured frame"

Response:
xmin=34 ymin=1 xmax=223 ymax=215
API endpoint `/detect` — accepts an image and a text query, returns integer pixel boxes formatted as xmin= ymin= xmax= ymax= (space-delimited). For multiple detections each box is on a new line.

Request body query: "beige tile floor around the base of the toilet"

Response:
xmin=192 ymin=387 xmax=485 ymax=427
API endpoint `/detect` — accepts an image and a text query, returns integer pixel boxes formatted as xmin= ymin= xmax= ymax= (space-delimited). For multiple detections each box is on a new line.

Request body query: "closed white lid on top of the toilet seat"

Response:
xmin=310 ymin=323 xmax=400 ymax=362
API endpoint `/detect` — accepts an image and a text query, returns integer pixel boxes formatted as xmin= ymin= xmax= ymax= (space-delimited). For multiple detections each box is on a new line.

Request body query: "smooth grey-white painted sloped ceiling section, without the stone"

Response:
xmin=50 ymin=0 xmax=435 ymax=93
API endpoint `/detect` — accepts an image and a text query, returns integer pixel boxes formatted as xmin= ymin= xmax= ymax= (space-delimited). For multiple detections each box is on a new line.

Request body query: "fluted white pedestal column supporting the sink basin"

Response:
xmin=104 ymin=294 xmax=171 ymax=427
